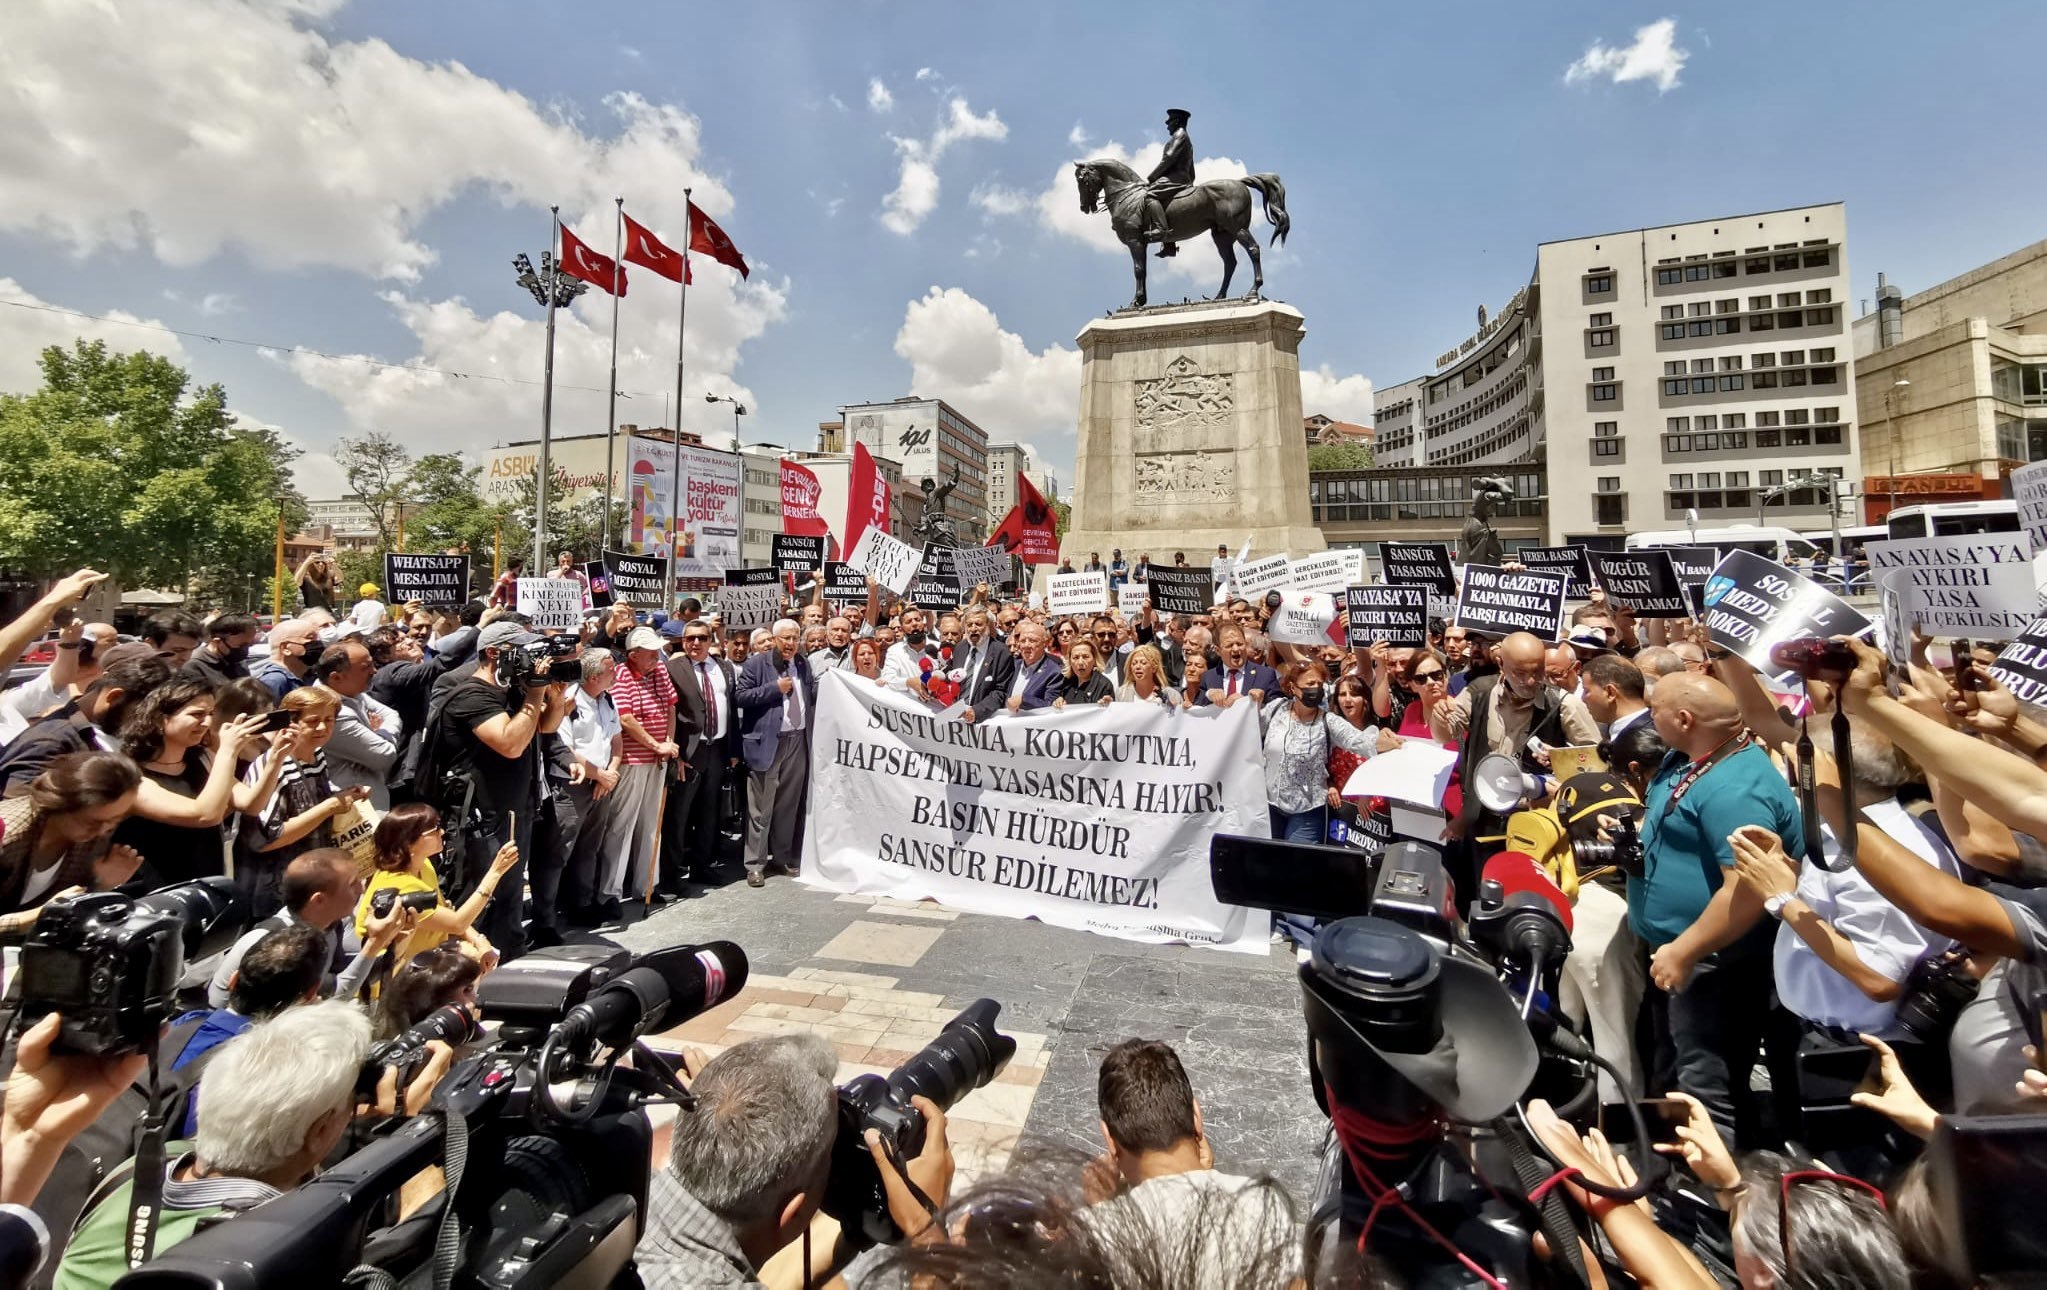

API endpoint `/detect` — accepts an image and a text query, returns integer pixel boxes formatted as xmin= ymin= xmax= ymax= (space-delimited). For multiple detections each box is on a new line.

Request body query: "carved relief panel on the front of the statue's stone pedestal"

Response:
xmin=1130 ymin=354 xmax=1236 ymax=506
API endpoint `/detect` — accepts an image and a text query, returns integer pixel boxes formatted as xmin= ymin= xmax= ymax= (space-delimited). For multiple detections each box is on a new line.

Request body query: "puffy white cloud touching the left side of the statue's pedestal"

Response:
xmin=895 ymin=287 xmax=1081 ymax=469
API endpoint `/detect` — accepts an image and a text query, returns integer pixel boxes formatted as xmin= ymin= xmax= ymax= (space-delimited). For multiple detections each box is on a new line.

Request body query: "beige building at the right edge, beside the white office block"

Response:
xmin=1855 ymin=242 xmax=2047 ymax=522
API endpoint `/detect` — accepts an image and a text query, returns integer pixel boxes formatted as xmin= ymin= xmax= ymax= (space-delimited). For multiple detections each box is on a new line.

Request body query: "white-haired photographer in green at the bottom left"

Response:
xmin=55 ymin=1001 xmax=371 ymax=1290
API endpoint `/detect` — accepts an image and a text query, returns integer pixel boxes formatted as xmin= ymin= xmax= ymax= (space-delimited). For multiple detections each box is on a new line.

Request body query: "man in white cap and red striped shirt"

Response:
xmin=598 ymin=627 xmax=682 ymax=901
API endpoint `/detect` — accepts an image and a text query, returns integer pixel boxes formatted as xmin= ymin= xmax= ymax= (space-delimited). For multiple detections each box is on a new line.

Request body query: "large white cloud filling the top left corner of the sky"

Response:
xmin=0 ymin=0 xmax=753 ymax=281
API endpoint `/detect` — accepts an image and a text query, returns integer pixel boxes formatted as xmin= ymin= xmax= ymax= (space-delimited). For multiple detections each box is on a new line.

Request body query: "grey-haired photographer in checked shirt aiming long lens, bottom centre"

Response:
xmin=635 ymin=1034 xmax=952 ymax=1290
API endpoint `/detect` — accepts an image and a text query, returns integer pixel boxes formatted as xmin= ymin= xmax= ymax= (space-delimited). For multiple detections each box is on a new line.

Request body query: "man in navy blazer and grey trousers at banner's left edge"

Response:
xmin=739 ymin=618 xmax=817 ymax=887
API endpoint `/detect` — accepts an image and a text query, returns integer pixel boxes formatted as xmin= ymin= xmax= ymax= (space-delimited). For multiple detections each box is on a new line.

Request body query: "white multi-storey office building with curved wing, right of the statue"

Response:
xmin=1351 ymin=203 xmax=1859 ymax=549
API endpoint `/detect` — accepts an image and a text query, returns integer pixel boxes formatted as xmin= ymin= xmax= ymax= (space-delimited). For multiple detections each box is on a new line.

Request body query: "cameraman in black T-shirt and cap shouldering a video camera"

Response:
xmin=436 ymin=618 xmax=575 ymax=958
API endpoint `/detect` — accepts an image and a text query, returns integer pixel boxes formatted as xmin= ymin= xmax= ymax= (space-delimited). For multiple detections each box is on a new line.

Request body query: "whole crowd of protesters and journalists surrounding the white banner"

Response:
xmin=0 ymin=551 xmax=2047 ymax=1288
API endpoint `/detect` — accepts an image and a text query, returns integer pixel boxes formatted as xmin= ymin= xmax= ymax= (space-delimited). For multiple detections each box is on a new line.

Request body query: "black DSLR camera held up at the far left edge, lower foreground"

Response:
xmin=20 ymin=878 xmax=242 ymax=1057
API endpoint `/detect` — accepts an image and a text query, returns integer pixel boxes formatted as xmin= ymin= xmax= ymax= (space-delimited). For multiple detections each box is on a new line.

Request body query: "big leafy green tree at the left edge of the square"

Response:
xmin=0 ymin=340 xmax=305 ymax=602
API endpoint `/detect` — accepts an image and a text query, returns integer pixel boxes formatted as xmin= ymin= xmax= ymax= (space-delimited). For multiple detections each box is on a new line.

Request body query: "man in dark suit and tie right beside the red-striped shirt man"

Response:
xmin=661 ymin=618 xmax=739 ymax=887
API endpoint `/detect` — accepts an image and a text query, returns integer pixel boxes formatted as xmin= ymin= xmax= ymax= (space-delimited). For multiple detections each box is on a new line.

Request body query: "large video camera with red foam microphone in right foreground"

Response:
xmin=1210 ymin=833 xmax=1654 ymax=1286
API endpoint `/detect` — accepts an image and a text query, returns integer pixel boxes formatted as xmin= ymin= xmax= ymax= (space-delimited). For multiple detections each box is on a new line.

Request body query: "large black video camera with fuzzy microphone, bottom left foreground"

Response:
xmin=117 ymin=942 xmax=747 ymax=1290
